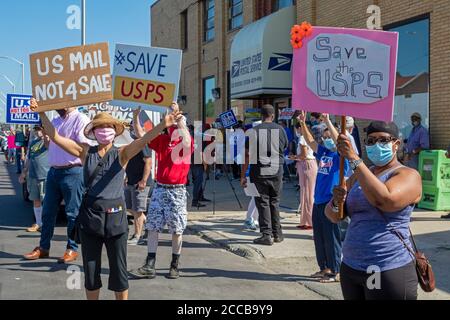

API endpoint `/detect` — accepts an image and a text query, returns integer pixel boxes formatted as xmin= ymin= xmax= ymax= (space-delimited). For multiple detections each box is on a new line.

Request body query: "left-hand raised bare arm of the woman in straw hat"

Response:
xmin=30 ymin=98 xmax=89 ymax=160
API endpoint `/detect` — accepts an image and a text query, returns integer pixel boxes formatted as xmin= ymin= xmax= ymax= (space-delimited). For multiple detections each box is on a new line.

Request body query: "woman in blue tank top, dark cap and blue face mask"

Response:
xmin=326 ymin=122 xmax=422 ymax=300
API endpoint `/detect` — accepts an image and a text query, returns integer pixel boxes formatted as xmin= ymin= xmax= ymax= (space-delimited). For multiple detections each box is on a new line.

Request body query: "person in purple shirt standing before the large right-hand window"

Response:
xmin=405 ymin=112 xmax=430 ymax=170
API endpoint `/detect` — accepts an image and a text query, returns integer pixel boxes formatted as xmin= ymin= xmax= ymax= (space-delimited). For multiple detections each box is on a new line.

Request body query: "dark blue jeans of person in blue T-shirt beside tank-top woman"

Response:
xmin=312 ymin=203 xmax=342 ymax=273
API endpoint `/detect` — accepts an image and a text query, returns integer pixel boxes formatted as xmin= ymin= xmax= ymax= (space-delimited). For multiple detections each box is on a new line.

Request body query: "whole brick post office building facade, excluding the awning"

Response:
xmin=151 ymin=0 xmax=450 ymax=149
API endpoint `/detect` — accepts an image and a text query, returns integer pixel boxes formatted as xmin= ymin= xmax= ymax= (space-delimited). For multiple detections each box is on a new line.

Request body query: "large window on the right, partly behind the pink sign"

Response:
xmin=385 ymin=17 xmax=430 ymax=139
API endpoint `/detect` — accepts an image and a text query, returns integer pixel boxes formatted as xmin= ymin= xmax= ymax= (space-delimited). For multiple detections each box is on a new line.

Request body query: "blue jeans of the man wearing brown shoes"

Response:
xmin=40 ymin=167 xmax=83 ymax=251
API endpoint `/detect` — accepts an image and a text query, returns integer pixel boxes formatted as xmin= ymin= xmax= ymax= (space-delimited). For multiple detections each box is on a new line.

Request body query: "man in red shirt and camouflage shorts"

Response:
xmin=131 ymin=102 xmax=194 ymax=279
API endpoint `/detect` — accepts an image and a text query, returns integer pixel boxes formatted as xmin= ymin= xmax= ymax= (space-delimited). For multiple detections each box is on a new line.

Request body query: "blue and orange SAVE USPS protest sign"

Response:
xmin=112 ymin=44 xmax=182 ymax=112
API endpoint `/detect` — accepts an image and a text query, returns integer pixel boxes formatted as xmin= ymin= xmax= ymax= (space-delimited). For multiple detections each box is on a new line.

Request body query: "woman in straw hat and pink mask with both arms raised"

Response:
xmin=27 ymin=99 xmax=181 ymax=300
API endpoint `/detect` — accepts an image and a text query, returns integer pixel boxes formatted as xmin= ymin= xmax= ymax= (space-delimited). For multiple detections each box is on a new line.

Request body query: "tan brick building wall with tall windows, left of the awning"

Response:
xmin=151 ymin=0 xmax=295 ymax=122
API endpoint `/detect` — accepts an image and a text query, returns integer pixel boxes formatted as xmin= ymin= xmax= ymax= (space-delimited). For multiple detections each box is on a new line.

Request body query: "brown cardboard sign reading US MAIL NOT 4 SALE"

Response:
xmin=30 ymin=43 xmax=112 ymax=111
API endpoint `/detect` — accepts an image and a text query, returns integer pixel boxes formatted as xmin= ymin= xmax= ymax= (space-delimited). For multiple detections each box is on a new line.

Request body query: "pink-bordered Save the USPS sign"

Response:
xmin=292 ymin=27 xmax=398 ymax=121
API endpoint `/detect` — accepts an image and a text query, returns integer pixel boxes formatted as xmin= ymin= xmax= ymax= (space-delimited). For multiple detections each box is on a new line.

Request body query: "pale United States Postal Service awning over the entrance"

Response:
xmin=230 ymin=6 xmax=296 ymax=99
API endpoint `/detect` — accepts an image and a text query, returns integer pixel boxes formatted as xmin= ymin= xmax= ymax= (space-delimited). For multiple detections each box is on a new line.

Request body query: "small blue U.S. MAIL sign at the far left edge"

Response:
xmin=6 ymin=94 xmax=41 ymax=124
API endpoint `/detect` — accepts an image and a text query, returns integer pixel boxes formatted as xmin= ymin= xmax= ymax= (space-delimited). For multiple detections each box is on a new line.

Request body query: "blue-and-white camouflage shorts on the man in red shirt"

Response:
xmin=147 ymin=185 xmax=187 ymax=234
